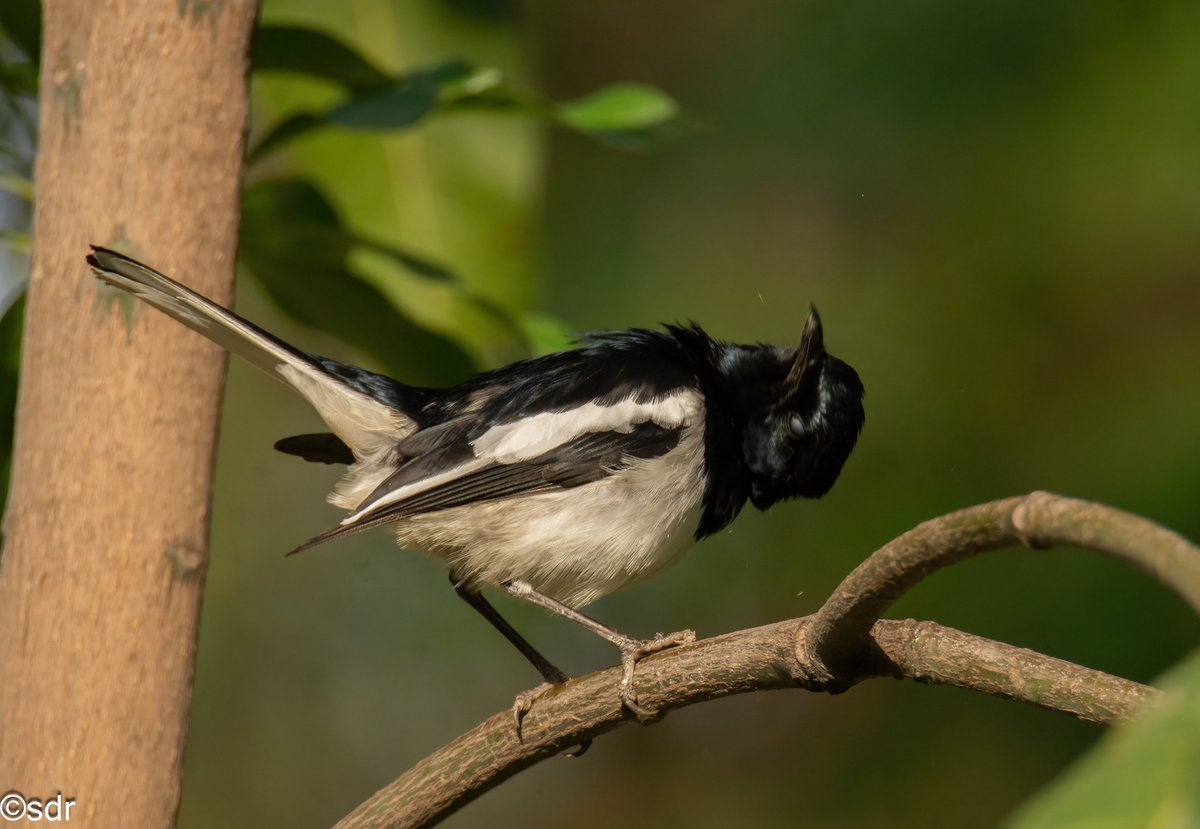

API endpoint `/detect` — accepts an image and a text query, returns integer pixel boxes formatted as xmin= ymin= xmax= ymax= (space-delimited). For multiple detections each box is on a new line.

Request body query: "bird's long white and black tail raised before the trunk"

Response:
xmin=88 ymin=247 xmax=419 ymax=461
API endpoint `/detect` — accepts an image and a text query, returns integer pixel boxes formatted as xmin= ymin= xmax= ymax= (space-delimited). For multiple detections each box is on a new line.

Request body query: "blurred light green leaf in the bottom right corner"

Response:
xmin=1006 ymin=651 xmax=1200 ymax=829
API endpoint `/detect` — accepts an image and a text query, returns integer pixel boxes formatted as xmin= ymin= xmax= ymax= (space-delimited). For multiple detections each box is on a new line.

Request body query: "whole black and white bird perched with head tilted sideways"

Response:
xmin=88 ymin=247 xmax=864 ymax=726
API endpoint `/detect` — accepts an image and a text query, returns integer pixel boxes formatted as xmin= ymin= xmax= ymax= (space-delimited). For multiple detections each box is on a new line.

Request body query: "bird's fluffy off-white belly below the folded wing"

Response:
xmin=384 ymin=423 xmax=704 ymax=607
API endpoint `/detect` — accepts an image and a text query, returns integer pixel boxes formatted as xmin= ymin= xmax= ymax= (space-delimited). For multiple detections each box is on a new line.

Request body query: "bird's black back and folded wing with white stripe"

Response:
xmin=285 ymin=332 xmax=703 ymax=552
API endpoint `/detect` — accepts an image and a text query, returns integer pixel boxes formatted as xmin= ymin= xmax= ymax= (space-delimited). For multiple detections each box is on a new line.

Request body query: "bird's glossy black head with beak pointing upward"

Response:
xmin=742 ymin=308 xmax=865 ymax=510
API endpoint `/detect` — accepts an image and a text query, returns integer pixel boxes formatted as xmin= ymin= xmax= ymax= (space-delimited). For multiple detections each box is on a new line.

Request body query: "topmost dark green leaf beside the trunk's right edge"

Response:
xmin=251 ymin=25 xmax=391 ymax=89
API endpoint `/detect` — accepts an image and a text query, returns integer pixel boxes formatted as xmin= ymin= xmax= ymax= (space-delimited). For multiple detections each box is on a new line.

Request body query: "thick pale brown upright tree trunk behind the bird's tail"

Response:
xmin=0 ymin=0 xmax=257 ymax=829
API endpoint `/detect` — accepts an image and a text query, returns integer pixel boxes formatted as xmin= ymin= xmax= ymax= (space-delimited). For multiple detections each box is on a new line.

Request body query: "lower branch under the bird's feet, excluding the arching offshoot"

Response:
xmin=336 ymin=617 xmax=1156 ymax=829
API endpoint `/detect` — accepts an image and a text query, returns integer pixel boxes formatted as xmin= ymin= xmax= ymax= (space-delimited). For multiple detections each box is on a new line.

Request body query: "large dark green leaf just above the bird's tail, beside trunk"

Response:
xmin=239 ymin=180 xmax=474 ymax=385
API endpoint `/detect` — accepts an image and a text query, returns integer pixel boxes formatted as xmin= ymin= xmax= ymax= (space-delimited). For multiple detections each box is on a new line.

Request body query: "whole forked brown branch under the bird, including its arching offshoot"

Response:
xmin=337 ymin=493 xmax=1200 ymax=829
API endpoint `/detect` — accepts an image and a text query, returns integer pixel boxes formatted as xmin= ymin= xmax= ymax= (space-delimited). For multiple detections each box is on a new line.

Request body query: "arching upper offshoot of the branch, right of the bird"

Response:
xmin=806 ymin=492 xmax=1200 ymax=680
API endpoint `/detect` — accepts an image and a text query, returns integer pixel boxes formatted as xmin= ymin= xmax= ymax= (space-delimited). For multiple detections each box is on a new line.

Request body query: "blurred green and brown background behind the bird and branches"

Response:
xmin=0 ymin=0 xmax=1200 ymax=829
